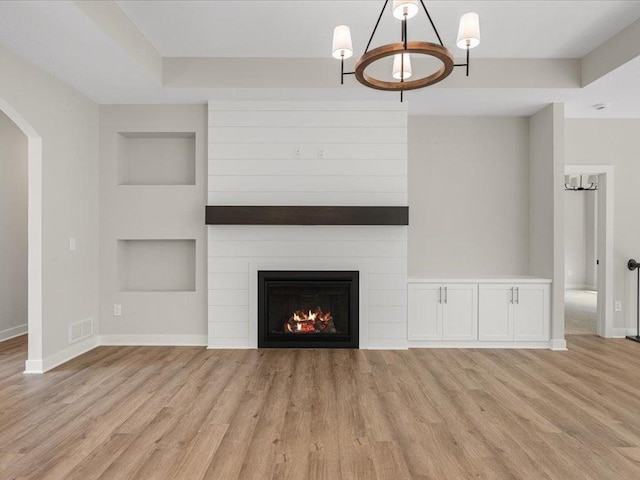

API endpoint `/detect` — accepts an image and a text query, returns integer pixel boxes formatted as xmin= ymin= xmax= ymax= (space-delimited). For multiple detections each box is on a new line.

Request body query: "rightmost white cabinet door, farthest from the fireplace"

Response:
xmin=514 ymin=284 xmax=550 ymax=342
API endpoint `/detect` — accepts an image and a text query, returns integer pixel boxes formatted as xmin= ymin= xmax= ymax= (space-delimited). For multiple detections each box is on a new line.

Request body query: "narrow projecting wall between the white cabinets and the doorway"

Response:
xmin=529 ymin=104 xmax=566 ymax=348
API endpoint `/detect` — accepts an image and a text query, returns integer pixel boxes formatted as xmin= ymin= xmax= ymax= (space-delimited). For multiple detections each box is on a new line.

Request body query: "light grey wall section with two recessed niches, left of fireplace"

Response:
xmin=100 ymin=105 xmax=207 ymax=345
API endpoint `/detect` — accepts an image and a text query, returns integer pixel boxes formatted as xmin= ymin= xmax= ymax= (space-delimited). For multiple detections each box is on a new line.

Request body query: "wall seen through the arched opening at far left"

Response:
xmin=0 ymin=111 xmax=27 ymax=341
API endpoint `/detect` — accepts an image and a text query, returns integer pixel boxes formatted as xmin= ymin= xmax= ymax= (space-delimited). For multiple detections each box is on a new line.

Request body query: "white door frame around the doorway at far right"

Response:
xmin=564 ymin=165 xmax=614 ymax=338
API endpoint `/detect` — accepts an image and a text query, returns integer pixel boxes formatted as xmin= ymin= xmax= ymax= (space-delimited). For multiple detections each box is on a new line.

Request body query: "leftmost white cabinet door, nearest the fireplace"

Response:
xmin=407 ymin=284 xmax=442 ymax=340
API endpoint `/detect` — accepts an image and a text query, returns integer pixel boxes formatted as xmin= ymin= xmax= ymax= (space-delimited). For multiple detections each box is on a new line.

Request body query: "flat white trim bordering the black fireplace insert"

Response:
xmin=249 ymin=259 xmax=372 ymax=350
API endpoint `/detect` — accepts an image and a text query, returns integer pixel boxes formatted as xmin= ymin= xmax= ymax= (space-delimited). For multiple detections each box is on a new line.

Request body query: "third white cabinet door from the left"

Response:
xmin=478 ymin=284 xmax=513 ymax=342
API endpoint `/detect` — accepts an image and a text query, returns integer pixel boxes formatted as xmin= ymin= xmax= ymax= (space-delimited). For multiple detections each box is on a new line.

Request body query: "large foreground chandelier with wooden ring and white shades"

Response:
xmin=333 ymin=0 xmax=480 ymax=101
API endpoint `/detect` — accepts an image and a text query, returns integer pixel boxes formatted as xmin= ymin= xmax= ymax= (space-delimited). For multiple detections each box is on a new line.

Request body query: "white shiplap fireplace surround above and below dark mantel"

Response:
xmin=207 ymin=102 xmax=407 ymax=348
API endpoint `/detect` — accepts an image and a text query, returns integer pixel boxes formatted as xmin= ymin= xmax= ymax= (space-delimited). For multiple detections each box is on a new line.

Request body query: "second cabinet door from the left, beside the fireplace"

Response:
xmin=442 ymin=284 xmax=478 ymax=340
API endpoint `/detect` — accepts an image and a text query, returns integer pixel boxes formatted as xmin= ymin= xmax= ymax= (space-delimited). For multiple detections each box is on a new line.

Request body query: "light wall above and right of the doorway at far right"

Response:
xmin=566 ymin=119 xmax=640 ymax=334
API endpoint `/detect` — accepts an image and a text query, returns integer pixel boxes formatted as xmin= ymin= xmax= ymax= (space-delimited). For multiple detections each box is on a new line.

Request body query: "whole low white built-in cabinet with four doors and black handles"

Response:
xmin=408 ymin=279 xmax=550 ymax=346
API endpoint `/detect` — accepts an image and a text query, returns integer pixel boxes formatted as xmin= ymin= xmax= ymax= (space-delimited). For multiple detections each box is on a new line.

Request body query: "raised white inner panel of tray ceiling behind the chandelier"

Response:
xmin=116 ymin=0 xmax=640 ymax=58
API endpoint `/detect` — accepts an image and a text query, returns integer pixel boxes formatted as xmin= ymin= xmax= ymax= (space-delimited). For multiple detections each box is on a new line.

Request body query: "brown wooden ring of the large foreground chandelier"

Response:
xmin=355 ymin=41 xmax=454 ymax=92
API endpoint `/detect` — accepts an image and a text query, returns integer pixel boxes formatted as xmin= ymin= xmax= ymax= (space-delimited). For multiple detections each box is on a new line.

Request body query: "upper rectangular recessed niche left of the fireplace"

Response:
xmin=117 ymin=132 xmax=196 ymax=185
